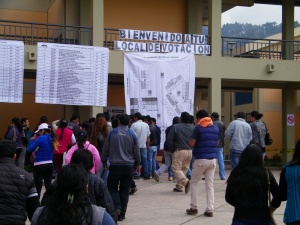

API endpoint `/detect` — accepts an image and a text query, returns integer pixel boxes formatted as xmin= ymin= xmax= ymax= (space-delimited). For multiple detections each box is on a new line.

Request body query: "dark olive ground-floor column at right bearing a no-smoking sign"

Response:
xmin=282 ymin=88 xmax=296 ymax=163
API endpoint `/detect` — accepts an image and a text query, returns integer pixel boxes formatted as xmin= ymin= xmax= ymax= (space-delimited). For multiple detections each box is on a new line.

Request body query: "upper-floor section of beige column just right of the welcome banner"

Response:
xmin=208 ymin=0 xmax=222 ymax=57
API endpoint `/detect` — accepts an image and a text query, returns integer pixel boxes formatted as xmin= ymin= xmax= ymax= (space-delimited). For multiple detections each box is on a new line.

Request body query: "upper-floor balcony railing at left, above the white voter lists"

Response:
xmin=0 ymin=20 xmax=92 ymax=45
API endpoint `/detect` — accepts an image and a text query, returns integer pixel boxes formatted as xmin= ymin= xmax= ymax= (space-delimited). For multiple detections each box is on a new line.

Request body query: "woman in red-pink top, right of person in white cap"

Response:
xmin=54 ymin=119 xmax=76 ymax=173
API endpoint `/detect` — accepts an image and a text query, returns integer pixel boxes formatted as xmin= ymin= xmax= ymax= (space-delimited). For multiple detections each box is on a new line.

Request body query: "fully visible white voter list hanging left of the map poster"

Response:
xmin=35 ymin=43 xmax=109 ymax=106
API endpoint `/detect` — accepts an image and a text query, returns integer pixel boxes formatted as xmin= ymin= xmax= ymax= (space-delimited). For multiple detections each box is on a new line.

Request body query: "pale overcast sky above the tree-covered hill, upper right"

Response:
xmin=222 ymin=4 xmax=300 ymax=25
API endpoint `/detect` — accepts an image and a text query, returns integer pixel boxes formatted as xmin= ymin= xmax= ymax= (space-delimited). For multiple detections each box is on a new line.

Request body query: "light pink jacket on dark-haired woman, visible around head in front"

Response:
xmin=65 ymin=141 xmax=101 ymax=174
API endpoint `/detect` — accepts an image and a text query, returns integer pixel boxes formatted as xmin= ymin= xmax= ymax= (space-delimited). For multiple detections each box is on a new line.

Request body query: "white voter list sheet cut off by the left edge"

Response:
xmin=0 ymin=40 xmax=24 ymax=103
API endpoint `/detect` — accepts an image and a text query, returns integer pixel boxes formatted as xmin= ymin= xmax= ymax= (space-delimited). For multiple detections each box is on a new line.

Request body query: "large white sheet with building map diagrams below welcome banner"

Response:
xmin=124 ymin=53 xmax=195 ymax=146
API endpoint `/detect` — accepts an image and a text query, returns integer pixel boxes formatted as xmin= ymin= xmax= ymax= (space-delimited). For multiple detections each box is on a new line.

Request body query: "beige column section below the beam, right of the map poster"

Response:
xmin=208 ymin=77 xmax=222 ymax=118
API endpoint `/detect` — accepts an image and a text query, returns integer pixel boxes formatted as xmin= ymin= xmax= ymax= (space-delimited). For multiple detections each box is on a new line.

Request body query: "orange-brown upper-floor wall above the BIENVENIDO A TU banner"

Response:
xmin=104 ymin=0 xmax=185 ymax=33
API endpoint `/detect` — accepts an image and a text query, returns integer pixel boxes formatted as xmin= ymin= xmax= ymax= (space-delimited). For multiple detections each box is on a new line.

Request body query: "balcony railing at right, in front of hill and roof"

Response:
xmin=222 ymin=37 xmax=300 ymax=60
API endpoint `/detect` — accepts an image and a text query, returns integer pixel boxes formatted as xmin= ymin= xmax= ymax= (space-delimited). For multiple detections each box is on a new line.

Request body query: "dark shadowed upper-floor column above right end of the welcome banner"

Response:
xmin=185 ymin=0 xmax=203 ymax=34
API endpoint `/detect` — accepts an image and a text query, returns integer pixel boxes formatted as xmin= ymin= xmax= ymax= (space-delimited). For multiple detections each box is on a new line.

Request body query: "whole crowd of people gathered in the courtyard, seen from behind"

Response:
xmin=0 ymin=110 xmax=300 ymax=225
